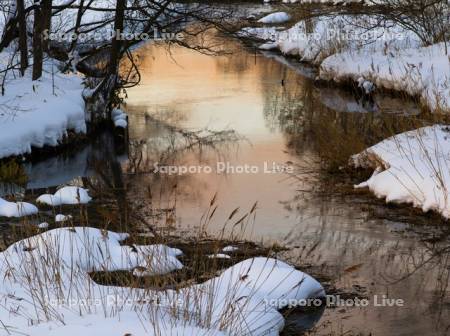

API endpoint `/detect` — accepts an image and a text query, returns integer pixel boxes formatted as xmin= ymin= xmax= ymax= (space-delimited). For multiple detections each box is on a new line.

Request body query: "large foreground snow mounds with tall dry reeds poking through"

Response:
xmin=0 ymin=227 xmax=324 ymax=336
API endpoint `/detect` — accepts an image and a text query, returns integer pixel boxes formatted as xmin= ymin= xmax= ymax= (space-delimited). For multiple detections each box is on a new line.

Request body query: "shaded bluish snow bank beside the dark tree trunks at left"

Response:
xmin=0 ymin=58 xmax=86 ymax=158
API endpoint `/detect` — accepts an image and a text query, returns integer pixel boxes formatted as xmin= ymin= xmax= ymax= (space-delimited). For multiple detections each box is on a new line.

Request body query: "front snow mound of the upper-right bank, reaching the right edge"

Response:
xmin=320 ymin=43 xmax=450 ymax=112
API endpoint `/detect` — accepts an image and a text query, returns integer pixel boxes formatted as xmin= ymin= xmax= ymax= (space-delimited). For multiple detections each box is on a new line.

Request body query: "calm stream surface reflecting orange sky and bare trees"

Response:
xmin=125 ymin=42 xmax=449 ymax=335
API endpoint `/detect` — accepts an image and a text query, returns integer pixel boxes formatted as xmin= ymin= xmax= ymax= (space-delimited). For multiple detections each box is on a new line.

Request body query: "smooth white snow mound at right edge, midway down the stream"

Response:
xmin=351 ymin=125 xmax=450 ymax=218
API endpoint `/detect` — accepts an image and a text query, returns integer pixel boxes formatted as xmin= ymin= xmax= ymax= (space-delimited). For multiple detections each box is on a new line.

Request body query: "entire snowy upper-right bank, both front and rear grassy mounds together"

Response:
xmin=240 ymin=15 xmax=450 ymax=112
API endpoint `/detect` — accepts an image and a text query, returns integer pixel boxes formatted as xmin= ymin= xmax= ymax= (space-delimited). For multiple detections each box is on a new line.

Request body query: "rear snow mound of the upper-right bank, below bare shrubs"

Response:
xmin=240 ymin=15 xmax=420 ymax=65
